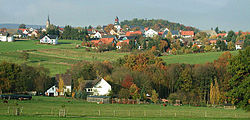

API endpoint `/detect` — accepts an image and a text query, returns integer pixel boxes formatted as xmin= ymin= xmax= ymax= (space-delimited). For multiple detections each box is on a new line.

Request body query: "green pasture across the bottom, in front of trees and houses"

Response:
xmin=0 ymin=96 xmax=250 ymax=120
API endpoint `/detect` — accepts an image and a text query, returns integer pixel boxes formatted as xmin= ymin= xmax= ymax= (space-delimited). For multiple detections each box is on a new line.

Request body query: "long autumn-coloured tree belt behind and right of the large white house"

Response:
xmin=68 ymin=47 xmax=250 ymax=109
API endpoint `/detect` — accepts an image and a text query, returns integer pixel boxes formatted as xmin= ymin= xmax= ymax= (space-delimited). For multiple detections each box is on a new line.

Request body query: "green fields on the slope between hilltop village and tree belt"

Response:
xmin=0 ymin=40 xmax=237 ymax=76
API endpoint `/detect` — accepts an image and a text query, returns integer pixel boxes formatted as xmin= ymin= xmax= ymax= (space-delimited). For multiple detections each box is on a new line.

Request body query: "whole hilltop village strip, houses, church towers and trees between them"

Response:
xmin=0 ymin=17 xmax=250 ymax=54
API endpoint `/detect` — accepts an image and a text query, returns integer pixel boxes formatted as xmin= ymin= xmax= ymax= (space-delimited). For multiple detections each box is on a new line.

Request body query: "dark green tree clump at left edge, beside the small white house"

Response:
xmin=0 ymin=61 xmax=55 ymax=94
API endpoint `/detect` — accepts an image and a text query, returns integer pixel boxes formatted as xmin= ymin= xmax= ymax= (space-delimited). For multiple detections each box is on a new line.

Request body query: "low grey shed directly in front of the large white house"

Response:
xmin=87 ymin=96 xmax=110 ymax=104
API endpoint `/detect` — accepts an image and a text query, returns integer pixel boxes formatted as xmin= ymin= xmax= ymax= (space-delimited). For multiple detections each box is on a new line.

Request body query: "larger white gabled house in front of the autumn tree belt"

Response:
xmin=85 ymin=78 xmax=111 ymax=96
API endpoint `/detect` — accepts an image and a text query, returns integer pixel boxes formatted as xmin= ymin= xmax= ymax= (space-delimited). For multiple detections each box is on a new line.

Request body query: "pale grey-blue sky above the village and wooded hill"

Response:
xmin=0 ymin=0 xmax=250 ymax=31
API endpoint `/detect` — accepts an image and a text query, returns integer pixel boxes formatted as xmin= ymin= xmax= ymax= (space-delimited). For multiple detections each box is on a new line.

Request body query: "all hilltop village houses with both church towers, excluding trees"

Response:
xmin=0 ymin=16 xmax=249 ymax=50
